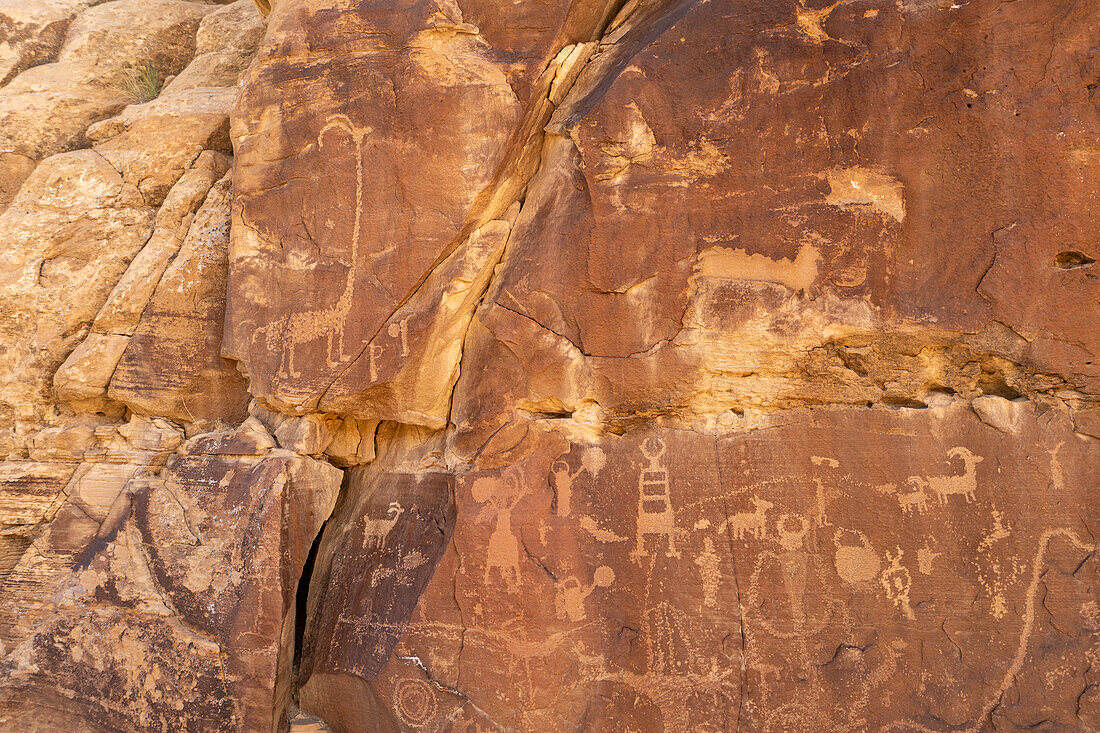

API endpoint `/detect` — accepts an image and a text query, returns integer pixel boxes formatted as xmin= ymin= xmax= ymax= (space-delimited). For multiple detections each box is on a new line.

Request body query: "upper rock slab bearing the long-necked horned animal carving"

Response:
xmin=227 ymin=1 xmax=609 ymax=422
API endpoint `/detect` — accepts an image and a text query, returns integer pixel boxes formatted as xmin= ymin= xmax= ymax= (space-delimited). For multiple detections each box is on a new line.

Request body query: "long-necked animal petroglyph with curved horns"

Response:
xmin=256 ymin=114 xmax=372 ymax=378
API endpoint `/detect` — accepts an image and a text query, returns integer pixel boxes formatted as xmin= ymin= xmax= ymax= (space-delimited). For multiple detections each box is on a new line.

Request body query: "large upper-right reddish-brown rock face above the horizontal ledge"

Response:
xmin=446 ymin=2 xmax=1100 ymax=450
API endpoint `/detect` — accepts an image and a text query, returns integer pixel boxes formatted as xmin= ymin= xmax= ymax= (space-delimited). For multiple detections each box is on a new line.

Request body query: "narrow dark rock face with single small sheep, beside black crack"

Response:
xmin=298 ymin=467 xmax=454 ymax=730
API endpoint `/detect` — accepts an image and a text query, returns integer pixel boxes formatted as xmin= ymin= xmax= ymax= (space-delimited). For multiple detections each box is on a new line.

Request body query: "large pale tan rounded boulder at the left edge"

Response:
xmin=0 ymin=145 xmax=155 ymax=433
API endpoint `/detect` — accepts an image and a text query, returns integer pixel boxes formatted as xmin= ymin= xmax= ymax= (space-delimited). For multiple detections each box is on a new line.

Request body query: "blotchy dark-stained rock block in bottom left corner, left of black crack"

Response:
xmin=0 ymin=413 xmax=341 ymax=731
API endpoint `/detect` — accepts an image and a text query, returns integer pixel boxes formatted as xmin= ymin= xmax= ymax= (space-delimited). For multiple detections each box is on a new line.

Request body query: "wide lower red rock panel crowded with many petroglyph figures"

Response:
xmin=308 ymin=401 xmax=1100 ymax=731
